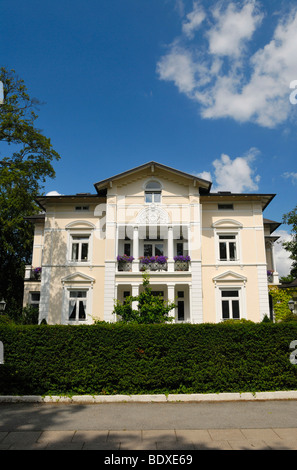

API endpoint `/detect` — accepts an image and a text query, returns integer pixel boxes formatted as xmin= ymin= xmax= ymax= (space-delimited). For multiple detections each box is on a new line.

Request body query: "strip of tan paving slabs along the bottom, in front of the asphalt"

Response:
xmin=0 ymin=428 xmax=297 ymax=453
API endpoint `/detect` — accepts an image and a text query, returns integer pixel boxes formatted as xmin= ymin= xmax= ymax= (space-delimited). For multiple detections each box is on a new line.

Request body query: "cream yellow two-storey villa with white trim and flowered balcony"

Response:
xmin=24 ymin=162 xmax=279 ymax=324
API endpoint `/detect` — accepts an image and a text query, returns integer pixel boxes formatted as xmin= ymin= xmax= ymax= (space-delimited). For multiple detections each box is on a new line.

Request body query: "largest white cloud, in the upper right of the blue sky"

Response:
xmin=157 ymin=0 xmax=297 ymax=128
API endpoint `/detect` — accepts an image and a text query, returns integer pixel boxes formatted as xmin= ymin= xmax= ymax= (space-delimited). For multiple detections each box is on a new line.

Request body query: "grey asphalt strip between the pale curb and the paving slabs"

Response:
xmin=0 ymin=400 xmax=297 ymax=432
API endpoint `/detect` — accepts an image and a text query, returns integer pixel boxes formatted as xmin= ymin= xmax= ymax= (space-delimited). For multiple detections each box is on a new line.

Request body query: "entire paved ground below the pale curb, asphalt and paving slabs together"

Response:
xmin=0 ymin=394 xmax=297 ymax=455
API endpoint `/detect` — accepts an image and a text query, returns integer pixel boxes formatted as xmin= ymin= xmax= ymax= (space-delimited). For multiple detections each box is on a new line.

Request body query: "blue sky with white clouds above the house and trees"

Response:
xmin=0 ymin=0 xmax=297 ymax=274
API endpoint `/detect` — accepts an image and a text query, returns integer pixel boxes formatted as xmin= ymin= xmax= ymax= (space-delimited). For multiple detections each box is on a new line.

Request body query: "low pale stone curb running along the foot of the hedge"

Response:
xmin=0 ymin=390 xmax=297 ymax=404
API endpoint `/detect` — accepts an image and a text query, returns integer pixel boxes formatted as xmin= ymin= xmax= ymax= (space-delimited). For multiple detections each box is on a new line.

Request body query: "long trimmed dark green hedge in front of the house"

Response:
xmin=0 ymin=322 xmax=297 ymax=395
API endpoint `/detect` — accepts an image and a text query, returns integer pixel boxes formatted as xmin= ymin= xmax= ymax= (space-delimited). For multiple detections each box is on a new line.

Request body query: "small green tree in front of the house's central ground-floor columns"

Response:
xmin=113 ymin=273 xmax=176 ymax=324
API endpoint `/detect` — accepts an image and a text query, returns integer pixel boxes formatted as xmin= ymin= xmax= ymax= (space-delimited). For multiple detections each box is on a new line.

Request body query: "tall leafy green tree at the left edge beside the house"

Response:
xmin=0 ymin=67 xmax=60 ymax=309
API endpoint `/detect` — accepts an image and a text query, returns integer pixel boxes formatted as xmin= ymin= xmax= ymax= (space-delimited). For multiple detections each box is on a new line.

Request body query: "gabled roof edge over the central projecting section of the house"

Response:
xmin=94 ymin=161 xmax=212 ymax=193
